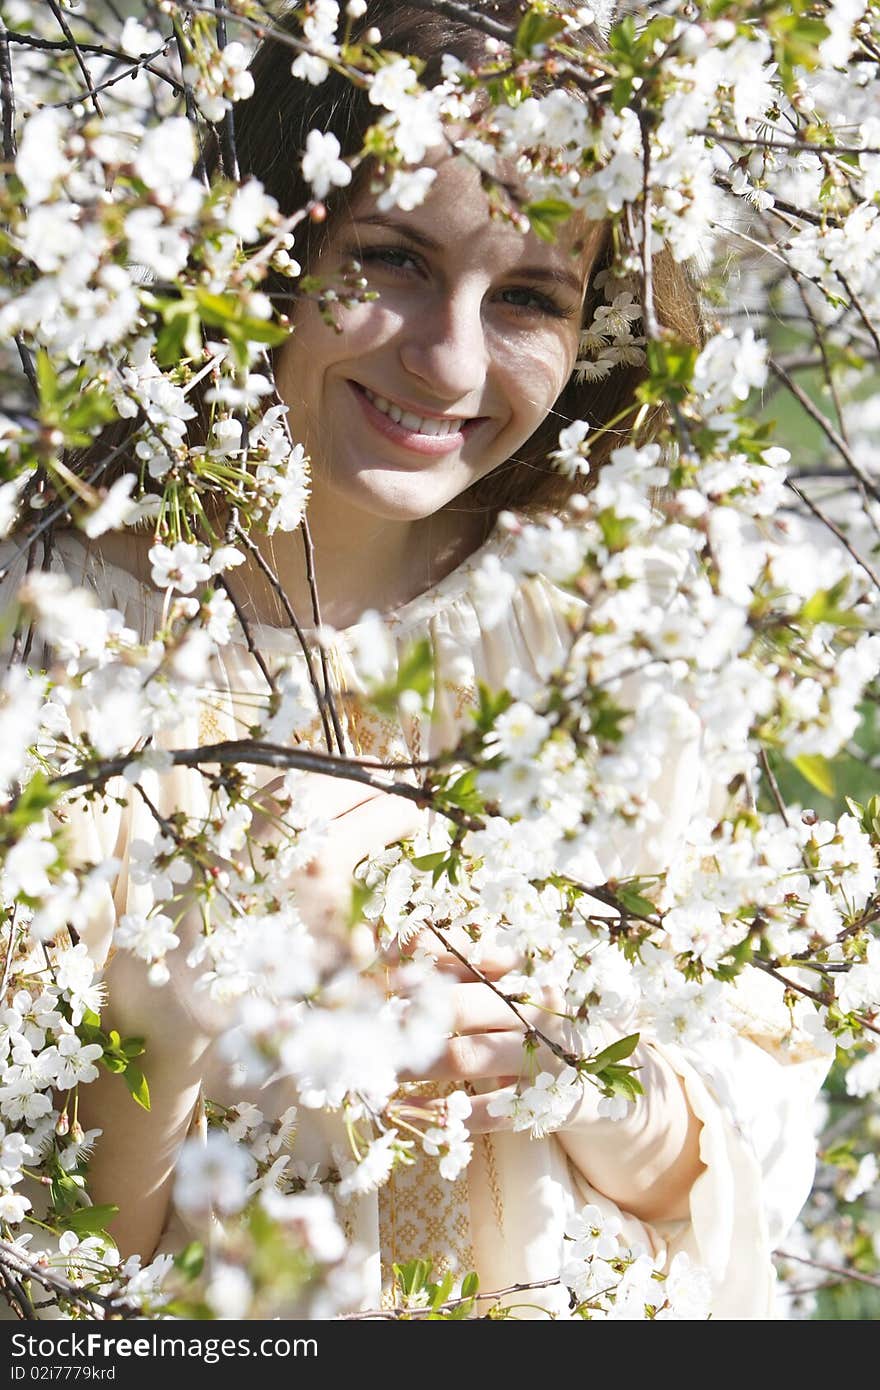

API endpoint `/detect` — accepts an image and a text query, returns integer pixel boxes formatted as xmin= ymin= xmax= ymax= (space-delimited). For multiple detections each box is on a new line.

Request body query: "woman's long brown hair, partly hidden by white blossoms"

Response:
xmin=67 ymin=0 xmax=702 ymax=531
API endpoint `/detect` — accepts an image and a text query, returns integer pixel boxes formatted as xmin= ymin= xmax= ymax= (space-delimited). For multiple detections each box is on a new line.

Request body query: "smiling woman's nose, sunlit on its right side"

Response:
xmin=399 ymin=285 xmax=489 ymax=404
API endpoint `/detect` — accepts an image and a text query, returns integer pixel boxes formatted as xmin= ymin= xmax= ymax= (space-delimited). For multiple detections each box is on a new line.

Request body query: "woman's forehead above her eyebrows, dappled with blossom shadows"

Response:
xmin=331 ymin=150 xmax=603 ymax=279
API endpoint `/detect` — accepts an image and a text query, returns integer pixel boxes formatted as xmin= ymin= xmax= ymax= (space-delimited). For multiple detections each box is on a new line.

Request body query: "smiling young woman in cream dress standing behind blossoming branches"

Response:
xmin=6 ymin=3 xmax=826 ymax=1318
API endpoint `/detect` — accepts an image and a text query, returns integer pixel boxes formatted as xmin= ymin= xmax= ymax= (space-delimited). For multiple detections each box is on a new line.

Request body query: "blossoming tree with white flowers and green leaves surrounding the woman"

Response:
xmin=0 ymin=0 xmax=880 ymax=1318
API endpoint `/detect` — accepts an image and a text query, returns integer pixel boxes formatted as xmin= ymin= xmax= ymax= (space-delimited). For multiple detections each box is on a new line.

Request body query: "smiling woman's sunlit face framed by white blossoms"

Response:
xmin=277 ymin=154 xmax=601 ymax=521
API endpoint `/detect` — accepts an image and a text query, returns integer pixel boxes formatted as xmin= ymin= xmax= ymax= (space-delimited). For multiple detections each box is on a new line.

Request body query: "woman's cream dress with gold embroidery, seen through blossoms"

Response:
xmin=0 ymin=531 xmax=829 ymax=1319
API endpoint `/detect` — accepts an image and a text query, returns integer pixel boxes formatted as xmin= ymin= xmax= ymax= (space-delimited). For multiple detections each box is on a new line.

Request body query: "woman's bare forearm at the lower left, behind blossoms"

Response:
xmin=79 ymin=951 xmax=210 ymax=1261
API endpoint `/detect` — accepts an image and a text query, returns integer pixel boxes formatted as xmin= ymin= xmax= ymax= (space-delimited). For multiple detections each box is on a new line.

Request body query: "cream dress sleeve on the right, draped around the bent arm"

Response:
xmin=503 ymin=561 xmax=833 ymax=1319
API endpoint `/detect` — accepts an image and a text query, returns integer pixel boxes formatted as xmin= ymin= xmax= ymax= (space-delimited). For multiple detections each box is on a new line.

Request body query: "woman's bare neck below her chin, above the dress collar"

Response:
xmin=236 ymin=489 xmax=485 ymax=628
